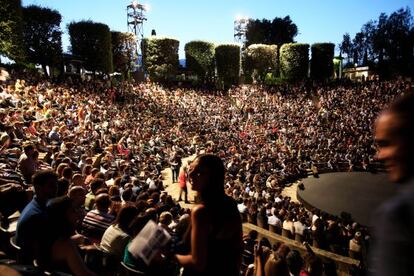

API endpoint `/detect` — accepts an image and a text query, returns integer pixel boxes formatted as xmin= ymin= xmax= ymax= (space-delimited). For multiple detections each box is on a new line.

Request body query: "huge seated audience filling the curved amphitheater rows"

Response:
xmin=0 ymin=68 xmax=410 ymax=275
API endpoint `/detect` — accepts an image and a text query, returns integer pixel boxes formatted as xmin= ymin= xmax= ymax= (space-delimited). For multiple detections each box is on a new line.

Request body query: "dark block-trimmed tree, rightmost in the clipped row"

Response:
xmin=311 ymin=43 xmax=335 ymax=80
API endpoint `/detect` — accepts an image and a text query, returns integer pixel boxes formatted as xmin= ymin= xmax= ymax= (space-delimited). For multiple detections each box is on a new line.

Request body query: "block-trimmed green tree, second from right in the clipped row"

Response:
xmin=280 ymin=43 xmax=309 ymax=81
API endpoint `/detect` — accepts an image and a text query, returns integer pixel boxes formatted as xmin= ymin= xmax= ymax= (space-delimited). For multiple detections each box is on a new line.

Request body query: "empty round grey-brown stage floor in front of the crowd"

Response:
xmin=297 ymin=172 xmax=397 ymax=226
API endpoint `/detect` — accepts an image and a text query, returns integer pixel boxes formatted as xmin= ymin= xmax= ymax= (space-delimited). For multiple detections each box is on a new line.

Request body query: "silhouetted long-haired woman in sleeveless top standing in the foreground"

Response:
xmin=176 ymin=154 xmax=243 ymax=276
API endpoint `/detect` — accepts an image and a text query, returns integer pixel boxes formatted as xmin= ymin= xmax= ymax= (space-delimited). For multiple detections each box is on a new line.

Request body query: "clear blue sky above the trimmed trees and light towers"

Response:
xmin=22 ymin=0 xmax=414 ymax=58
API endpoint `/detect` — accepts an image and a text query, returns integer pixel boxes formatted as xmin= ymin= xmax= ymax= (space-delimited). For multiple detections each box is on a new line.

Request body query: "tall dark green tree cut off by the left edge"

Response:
xmin=0 ymin=0 xmax=25 ymax=62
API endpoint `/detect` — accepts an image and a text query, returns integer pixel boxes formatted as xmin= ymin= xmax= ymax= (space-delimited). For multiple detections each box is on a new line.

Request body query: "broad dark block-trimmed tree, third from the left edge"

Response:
xmin=68 ymin=21 xmax=113 ymax=73
